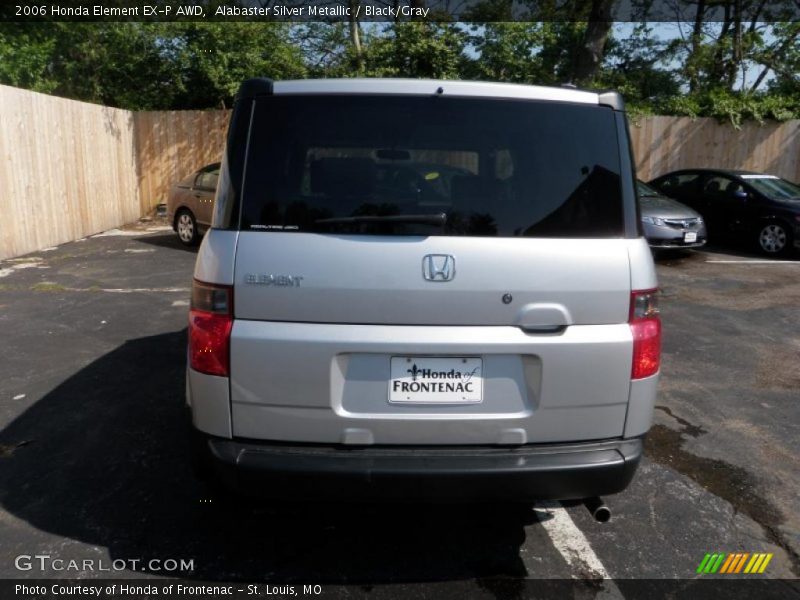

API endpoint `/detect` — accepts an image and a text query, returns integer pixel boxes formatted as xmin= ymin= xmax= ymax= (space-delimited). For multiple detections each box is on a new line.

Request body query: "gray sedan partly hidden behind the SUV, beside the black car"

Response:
xmin=637 ymin=181 xmax=706 ymax=248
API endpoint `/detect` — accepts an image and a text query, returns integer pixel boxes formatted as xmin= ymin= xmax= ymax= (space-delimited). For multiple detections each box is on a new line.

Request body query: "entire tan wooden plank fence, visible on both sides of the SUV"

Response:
xmin=0 ymin=86 xmax=800 ymax=259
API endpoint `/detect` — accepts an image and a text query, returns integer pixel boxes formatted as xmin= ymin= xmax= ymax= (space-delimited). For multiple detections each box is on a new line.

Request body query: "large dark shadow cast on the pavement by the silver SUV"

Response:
xmin=0 ymin=330 xmax=535 ymax=583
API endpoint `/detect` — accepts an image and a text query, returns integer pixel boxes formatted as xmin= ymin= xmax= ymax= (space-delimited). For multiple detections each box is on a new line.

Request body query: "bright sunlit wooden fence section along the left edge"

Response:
xmin=0 ymin=86 xmax=141 ymax=259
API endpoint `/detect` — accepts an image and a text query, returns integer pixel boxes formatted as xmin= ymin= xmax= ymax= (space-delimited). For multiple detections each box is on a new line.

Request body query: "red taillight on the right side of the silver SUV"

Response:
xmin=628 ymin=290 xmax=661 ymax=379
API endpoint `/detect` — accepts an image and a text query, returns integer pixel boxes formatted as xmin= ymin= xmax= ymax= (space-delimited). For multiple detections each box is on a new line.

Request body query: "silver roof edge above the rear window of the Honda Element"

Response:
xmin=238 ymin=78 xmax=624 ymax=110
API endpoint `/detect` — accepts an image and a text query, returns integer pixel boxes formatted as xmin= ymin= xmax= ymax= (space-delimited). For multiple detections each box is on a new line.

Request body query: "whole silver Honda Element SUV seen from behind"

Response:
xmin=187 ymin=79 xmax=661 ymax=501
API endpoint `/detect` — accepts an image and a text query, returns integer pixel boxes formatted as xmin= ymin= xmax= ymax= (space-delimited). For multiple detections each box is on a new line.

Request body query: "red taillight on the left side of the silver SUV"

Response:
xmin=189 ymin=281 xmax=233 ymax=377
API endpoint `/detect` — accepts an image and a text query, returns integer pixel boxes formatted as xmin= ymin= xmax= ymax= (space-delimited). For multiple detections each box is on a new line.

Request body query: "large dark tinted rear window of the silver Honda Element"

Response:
xmin=241 ymin=96 xmax=623 ymax=237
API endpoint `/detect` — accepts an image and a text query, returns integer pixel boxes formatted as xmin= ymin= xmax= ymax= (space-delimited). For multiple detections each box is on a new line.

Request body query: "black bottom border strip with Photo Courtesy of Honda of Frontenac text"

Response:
xmin=0 ymin=575 xmax=800 ymax=600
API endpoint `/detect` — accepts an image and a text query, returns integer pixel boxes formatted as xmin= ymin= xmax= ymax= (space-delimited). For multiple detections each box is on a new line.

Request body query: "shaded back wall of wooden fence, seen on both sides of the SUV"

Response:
xmin=134 ymin=110 xmax=800 ymax=210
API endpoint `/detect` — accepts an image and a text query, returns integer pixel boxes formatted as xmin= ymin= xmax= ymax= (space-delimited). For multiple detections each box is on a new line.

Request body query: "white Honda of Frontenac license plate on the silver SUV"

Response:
xmin=389 ymin=356 xmax=483 ymax=404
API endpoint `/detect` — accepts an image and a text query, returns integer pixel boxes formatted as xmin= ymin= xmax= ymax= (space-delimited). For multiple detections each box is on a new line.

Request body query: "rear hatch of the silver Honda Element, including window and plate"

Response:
xmin=223 ymin=89 xmax=643 ymax=445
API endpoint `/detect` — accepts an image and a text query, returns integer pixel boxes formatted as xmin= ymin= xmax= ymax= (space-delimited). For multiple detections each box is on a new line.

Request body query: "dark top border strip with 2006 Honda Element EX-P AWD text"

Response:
xmin=0 ymin=0 xmax=800 ymax=24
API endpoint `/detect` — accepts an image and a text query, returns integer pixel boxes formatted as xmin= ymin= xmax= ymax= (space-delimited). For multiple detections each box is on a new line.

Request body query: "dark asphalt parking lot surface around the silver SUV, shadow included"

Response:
xmin=0 ymin=222 xmax=800 ymax=597
